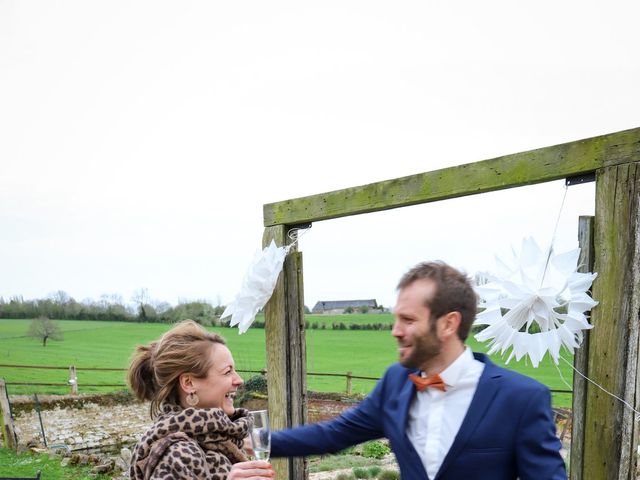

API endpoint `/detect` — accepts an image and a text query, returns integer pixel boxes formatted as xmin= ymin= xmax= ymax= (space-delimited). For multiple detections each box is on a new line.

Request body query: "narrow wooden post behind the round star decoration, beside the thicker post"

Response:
xmin=569 ymin=216 xmax=594 ymax=480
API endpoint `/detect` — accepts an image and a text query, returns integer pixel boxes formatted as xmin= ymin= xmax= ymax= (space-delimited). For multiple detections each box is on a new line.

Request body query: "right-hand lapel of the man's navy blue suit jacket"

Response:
xmin=436 ymin=353 xmax=502 ymax=478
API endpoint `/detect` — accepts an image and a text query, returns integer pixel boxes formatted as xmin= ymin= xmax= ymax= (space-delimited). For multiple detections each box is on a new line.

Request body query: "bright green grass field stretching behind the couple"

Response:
xmin=0 ymin=314 xmax=572 ymax=406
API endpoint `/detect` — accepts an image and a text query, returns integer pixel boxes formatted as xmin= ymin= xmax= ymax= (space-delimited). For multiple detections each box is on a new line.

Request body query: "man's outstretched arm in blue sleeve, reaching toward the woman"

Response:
xmin=271 ymin=379 xmax=384 ymax=457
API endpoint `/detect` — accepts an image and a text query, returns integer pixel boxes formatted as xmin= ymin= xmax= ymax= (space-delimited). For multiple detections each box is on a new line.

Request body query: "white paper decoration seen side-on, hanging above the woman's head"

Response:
xmin=220 ymin=240 xmax=293 ymax=334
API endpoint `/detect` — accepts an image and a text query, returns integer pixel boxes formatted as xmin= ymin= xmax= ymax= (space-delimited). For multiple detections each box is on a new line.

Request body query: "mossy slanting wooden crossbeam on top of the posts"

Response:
xmin=263 ymin=128 xmax=640 ymax=226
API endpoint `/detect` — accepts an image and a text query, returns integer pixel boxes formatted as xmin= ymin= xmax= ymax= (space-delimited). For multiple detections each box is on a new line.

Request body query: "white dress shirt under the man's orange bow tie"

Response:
xmin=407 ymin=347 xmax=484 ymax=479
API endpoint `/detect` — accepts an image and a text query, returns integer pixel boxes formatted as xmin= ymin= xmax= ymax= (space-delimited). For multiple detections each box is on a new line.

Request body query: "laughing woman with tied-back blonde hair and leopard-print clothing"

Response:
xmin=128 ymin=320 xmax=274 ymax=480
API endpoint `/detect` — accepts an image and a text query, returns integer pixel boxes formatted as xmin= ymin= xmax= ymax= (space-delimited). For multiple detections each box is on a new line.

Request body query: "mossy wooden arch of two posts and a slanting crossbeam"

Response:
xmin=263 ymin=128 xmax=640 ymax=480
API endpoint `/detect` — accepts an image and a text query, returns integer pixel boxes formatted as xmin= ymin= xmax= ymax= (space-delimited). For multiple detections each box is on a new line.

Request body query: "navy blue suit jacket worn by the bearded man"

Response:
xmin=271 ymin=353 xmax=567 ymax=480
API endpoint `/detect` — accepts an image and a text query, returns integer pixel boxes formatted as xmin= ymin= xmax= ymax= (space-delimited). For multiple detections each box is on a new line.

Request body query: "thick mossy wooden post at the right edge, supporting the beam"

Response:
xmin=582 ymin=163 xmax=640 ymax=480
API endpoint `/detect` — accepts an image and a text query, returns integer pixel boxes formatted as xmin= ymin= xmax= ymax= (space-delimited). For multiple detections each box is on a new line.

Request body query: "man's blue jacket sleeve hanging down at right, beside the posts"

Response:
xmin=516 ymin=388 xmax=567 ymax=480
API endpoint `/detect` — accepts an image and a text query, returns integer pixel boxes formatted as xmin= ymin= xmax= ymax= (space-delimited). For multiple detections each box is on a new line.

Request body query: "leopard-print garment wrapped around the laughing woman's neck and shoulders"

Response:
xmin=129 ymin=404 xmax=252 ymax=480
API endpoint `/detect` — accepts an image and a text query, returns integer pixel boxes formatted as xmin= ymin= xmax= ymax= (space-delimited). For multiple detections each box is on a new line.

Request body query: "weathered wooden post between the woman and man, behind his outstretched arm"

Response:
xmin=263 ymin=225 xmax=308 ymax=480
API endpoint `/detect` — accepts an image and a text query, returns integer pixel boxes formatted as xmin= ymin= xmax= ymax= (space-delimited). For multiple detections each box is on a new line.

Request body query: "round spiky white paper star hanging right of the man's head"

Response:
xmin=475 ymin=238 xmax=598 ymax=367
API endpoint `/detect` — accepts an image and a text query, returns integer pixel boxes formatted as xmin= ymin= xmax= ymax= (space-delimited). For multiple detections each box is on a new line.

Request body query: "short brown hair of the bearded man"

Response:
xmin=398 ymin=261 xmax=478 ymax=342
